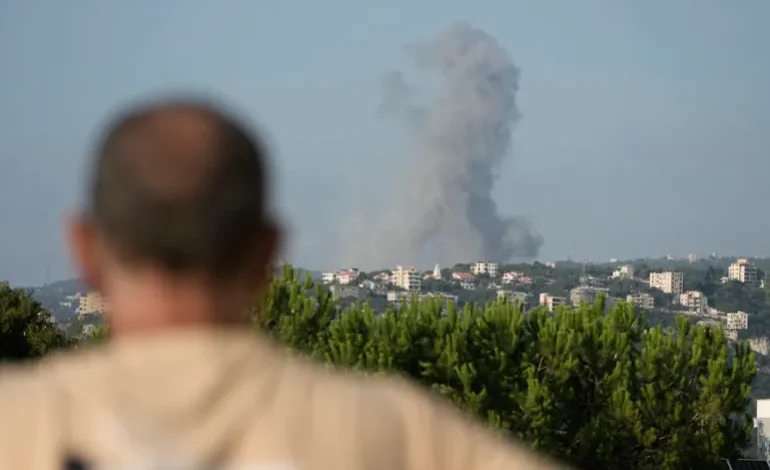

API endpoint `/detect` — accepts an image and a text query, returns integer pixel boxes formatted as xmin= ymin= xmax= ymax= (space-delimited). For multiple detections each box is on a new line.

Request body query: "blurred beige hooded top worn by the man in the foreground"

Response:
xmin=0 ymin=330 xmax=565 ymax=470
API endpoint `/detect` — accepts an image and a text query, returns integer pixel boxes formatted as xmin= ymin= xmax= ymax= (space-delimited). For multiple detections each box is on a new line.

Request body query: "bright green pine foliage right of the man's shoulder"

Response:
xmin=255 ymin=267 xmax=756 ymax=470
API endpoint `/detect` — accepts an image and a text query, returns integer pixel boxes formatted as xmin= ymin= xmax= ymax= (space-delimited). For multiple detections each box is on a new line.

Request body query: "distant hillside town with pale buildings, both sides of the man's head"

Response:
xmin=49 ymin=255 xmax=770 ymax=348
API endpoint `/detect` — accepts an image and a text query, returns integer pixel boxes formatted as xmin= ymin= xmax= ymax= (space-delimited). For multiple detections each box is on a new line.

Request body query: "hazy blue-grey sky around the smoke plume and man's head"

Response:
xmin=0 ymin=0 xmax=770 ymax=285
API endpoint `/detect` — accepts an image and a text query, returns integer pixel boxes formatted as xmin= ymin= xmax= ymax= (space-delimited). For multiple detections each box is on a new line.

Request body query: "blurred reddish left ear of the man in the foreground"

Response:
xmin=65 ymin=214 xmax=103 ymax=291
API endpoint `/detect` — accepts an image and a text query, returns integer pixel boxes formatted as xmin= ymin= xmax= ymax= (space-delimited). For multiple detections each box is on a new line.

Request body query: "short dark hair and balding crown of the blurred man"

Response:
xmin=88 ymin=100 xmax=270 ymax=277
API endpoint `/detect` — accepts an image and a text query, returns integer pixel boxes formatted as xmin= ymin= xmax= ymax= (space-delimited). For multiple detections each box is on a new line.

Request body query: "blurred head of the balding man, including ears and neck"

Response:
xmin=69 ymin=95 xmax=278 ymax=329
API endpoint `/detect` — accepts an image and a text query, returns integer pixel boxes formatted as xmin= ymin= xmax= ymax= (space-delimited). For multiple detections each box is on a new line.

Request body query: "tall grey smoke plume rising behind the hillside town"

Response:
xmin=344 ymin=23 xmax=543 ymax=266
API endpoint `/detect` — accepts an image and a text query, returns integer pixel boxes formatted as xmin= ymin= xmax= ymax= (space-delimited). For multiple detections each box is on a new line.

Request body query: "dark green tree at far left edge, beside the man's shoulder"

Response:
xmin=0 ymin=282 xmax=73 ymax=361
